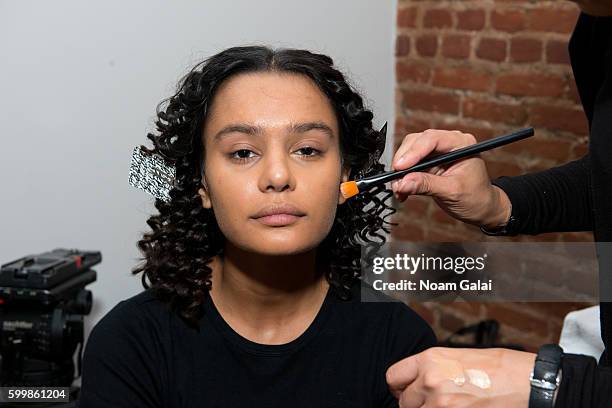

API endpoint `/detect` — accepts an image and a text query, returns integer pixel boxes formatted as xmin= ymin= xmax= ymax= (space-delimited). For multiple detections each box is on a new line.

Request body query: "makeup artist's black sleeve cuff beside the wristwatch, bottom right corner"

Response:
xmin=555 ymin=354 xmax=612 ymax=408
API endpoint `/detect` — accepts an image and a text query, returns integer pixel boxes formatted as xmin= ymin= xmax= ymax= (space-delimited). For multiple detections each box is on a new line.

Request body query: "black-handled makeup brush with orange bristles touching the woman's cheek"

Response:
xmin=340 ymin=128 xmax=534 ymax=198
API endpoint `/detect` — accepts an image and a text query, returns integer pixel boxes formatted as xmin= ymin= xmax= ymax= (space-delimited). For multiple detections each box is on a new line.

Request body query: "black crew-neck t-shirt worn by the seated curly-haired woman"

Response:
xmin=79 ymin=282 xmax=435 ymax=408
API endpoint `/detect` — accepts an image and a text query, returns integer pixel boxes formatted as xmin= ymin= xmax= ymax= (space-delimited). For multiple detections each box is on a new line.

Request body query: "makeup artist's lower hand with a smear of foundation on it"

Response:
xmin=387 ymin=347 xmax=536 ymax=408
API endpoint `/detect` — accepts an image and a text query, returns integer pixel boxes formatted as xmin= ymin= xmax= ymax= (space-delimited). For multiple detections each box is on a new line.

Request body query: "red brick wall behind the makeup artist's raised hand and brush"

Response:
xmin=392 ymin=0 xmax=592 ymax=350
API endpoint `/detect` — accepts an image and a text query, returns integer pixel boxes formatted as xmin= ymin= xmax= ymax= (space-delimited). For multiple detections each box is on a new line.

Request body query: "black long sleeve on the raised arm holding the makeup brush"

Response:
xmin=492 ymin=155 xmax=593 ymax=235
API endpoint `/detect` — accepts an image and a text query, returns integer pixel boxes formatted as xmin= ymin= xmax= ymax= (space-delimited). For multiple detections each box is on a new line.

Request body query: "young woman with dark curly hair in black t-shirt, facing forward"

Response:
xmin=80 ymin=47 xmax=435 ymax=408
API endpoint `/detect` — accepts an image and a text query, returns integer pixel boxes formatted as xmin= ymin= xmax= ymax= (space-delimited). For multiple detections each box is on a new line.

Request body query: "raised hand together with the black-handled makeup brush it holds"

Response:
xmin=340 ymin=128 xmax=534 ymax=226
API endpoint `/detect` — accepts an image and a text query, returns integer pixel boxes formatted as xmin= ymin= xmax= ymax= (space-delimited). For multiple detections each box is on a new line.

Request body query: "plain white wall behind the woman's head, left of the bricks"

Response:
xmin=0 ymin=0 xmax=396 ymax=340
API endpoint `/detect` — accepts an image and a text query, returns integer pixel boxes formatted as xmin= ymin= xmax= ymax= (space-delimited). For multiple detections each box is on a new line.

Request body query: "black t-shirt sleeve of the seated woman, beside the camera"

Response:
xmin=78 ymin=301 xmax=162 ymax=408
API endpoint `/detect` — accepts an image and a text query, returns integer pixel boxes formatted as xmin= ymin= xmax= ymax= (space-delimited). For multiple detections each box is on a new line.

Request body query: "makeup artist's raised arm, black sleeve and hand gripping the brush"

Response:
xmin=392 ymin=129 xmax=592 ymax=234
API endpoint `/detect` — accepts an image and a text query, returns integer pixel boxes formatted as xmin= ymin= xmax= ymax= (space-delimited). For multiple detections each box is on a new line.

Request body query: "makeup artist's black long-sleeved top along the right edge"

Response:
xmin=494 ymin=14 xmax=612 ymax=407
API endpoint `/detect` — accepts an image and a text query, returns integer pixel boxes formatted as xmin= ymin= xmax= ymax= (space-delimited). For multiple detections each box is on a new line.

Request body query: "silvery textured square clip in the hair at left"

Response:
xmin=129 ymin=146 xmax=176 ymax=202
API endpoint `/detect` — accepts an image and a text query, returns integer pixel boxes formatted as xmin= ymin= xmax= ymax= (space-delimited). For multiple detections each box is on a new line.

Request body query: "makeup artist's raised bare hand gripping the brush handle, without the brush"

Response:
xmin=391 ymin=129 xmax=511 ymax=227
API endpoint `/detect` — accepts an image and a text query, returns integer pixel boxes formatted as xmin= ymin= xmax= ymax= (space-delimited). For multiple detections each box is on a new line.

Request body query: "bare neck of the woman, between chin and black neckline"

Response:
xmin=210 ymin=245 xmax=329 ymax=344
